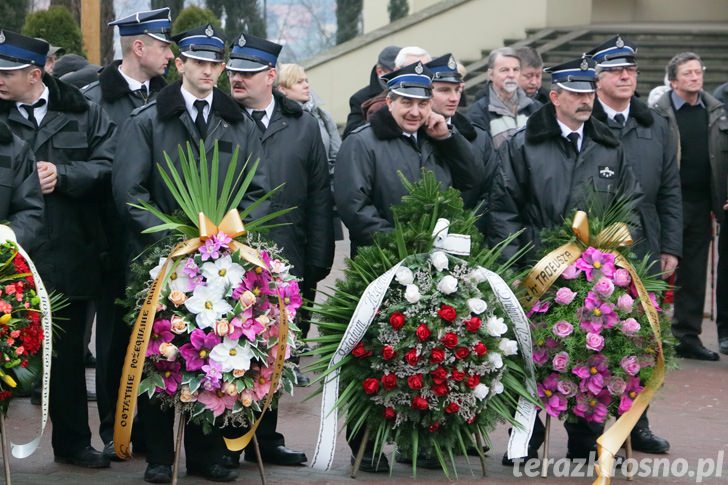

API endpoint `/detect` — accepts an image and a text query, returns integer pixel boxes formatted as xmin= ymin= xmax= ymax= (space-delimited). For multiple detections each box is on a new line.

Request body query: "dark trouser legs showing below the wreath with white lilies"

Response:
xmin=143 ymin=400 xmax=225 ymax=465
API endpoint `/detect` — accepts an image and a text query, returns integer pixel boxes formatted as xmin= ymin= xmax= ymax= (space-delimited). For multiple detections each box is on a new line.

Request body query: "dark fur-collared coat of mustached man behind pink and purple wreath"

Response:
xmin=487 ymin=104 xmax=641 ymax=257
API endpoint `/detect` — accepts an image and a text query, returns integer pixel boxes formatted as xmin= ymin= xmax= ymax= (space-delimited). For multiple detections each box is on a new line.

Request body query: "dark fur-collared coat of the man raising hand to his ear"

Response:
xmin=334 ymin=109 xmax=483 ymax=254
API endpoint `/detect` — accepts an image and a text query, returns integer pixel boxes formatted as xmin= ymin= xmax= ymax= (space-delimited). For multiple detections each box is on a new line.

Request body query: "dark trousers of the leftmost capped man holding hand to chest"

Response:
xmin=50 ymin=301 xmax=91 ymax=456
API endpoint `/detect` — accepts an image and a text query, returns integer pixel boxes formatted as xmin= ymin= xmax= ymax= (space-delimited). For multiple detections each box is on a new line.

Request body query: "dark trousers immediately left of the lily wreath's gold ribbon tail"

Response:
xmin=96 ymin=271 xmax=130 ymax=443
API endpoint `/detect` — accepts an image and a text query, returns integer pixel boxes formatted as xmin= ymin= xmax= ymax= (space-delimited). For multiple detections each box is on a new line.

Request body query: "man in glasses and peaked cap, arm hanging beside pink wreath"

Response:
xmin=587 ymin=35 xmax=683 ymax=453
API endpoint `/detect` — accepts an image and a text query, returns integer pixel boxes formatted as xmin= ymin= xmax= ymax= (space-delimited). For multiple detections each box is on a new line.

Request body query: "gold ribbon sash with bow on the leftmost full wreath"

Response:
xmin=114 ymin=209 xmax=288 ymax=459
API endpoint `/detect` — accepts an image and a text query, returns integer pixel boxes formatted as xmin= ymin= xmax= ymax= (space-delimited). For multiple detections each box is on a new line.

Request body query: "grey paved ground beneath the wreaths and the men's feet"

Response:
xmin=6 ymin=242 xmax=728 ymax=485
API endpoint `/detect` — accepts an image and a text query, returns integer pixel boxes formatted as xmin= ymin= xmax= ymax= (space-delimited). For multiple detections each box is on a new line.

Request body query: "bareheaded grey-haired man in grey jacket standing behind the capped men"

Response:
xmin=468 ymin=47 xmax=541 ymax=148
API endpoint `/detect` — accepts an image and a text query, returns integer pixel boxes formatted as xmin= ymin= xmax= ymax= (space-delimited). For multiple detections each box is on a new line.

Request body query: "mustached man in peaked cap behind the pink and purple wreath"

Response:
xmin=487 ymin=56 xmax=641 ymax=465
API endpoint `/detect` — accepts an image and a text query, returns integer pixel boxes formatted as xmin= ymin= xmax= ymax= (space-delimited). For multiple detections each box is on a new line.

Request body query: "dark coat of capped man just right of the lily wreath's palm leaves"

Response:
xmin=252 ymin=91 xmax=334 ymax=283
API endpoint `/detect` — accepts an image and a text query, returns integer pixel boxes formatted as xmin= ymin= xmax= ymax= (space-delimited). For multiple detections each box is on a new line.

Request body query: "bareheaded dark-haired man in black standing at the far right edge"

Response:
xmin=655 ymin=52 xmax=728 ymax=360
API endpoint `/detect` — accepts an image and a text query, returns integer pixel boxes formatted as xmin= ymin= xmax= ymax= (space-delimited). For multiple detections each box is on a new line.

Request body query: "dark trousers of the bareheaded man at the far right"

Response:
xmin=672 ymin=200 xmax=711 ymax=343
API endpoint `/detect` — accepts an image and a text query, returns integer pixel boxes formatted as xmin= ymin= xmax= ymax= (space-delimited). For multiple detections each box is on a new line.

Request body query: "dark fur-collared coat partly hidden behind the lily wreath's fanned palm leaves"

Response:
xmin=111 ymin=82 xmax=270 ymax=253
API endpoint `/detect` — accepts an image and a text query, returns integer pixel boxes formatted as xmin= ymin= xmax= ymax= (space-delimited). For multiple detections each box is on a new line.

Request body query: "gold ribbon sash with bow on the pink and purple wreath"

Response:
xmin=522 ymin=211 xmax=665 ymax=485
